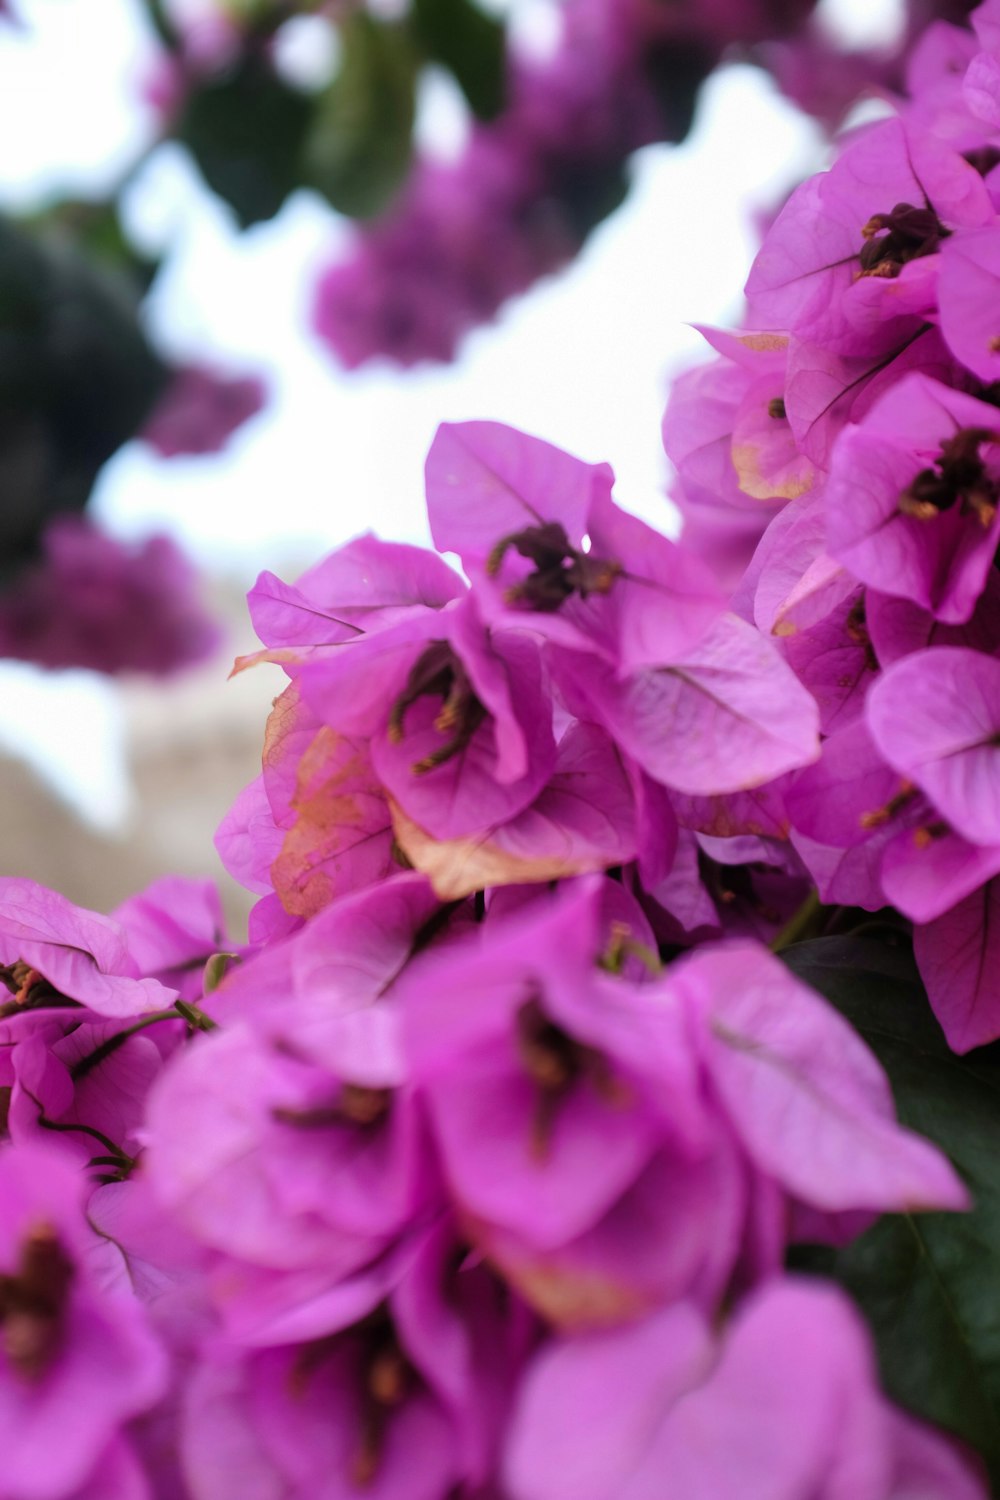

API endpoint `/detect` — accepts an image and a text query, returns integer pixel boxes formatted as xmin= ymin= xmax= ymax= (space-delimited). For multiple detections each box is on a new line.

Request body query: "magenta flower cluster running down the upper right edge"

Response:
xmin=664 ymin=0 xmax=1000 ymax=1052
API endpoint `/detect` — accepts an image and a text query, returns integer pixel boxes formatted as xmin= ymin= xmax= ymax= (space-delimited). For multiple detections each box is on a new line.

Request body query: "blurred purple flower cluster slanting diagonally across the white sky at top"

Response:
xmin=313 ymin=0 xmax=811 ymax=369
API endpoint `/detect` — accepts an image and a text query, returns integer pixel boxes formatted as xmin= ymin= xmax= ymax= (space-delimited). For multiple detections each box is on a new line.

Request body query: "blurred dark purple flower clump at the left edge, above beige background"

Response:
xmin=0 ymin=518 xmax=219 ymax=677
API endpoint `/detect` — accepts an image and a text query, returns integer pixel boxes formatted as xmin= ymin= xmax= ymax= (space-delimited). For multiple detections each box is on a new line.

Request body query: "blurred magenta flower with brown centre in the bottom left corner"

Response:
xmin=0 ymin=1146 xmax=166 ymax=1500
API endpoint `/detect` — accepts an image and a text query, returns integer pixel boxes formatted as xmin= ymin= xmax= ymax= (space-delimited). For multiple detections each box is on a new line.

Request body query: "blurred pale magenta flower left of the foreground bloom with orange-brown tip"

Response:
xmin=144 ymin=1013 xmax=426 ymax=1343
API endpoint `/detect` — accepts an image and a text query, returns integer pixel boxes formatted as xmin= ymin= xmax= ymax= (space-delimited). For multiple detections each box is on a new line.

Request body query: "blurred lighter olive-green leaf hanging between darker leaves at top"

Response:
xmin=304 ymin=11 xmax=418 ymax=219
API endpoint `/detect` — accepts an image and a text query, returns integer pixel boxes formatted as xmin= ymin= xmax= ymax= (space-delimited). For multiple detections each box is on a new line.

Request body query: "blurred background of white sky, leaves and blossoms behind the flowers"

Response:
xmin=0 ymin=0 xmax=907 ymax=921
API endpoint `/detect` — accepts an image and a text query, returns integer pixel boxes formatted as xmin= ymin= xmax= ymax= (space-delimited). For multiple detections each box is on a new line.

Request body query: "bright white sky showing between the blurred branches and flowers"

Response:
xmin=0 ymin=0 xmax=898 ymax=825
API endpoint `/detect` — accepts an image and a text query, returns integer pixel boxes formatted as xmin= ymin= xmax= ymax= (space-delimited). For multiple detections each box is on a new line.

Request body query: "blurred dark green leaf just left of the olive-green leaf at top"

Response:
xmin=175 ymin=51 xmax=313 ymax=228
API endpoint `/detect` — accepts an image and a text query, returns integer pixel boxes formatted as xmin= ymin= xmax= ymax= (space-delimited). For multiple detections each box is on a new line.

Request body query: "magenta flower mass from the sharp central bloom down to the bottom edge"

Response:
xmin=0 ymin=402 xmax=985 ymax=1500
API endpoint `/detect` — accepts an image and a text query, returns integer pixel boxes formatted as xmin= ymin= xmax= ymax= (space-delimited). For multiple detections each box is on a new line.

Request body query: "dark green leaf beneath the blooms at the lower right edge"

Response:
xmin=781 ymin=936 xmax=1000 ymax=1482
